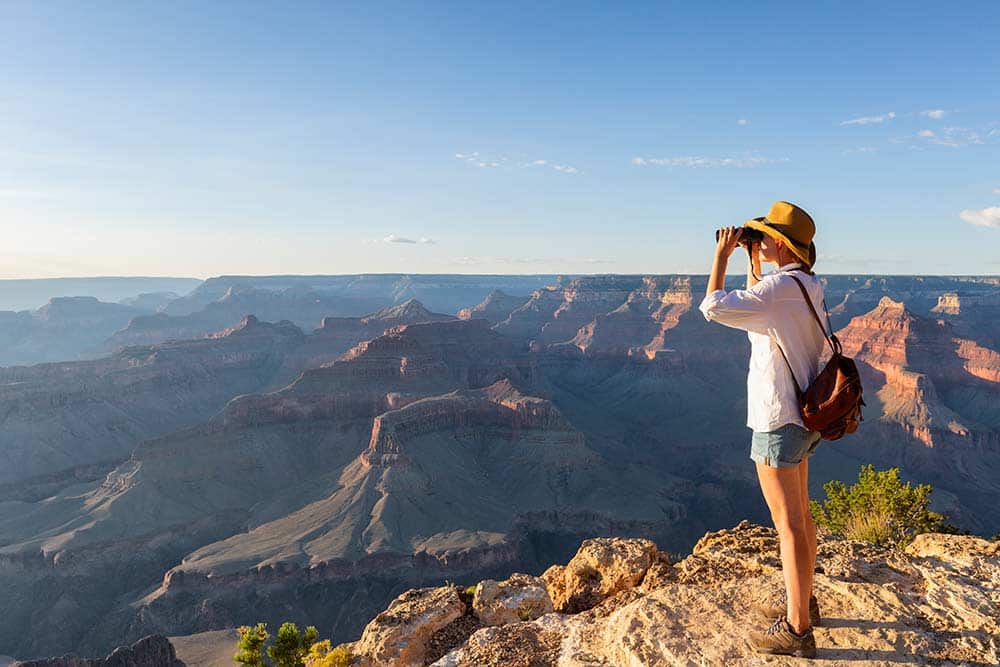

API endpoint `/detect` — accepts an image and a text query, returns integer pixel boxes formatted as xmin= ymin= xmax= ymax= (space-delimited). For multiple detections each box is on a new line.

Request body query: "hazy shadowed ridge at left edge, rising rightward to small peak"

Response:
xmin=0 ymin=317 xmax=303 ymax=498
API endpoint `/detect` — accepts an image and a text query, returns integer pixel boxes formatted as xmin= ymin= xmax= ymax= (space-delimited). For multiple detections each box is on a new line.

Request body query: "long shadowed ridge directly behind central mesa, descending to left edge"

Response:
xmin=0 ymin=318 xmax=556 ymax=654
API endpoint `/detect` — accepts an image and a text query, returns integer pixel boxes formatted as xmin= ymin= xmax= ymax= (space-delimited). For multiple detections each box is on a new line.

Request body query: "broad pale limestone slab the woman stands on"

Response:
xmin=424 ymin=522 xmax=1000 ymax=667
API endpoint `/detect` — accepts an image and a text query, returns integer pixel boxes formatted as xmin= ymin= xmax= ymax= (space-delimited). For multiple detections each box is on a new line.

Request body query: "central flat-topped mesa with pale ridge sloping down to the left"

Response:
xmin=119 ymin=379 xmax=685 ymax=648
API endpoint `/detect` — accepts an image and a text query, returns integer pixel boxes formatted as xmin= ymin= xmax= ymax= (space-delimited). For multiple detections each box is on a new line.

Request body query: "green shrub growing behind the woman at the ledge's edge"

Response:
xmin=809 ymin=465 xmax=945 ymax=549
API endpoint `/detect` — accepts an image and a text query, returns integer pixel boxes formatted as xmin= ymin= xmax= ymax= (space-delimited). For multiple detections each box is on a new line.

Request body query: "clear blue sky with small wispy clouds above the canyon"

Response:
xmin=0 ymin=2 xmax=1000 ymax=278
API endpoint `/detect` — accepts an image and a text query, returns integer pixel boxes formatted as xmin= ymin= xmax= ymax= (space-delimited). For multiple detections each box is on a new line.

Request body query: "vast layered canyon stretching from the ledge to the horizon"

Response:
xmin=0 ymin=275 xmax=1000 ymax=658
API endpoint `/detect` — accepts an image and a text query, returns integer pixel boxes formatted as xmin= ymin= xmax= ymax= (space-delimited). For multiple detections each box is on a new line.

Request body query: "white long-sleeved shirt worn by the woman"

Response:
xmin=699 ymin=263 xmax=826 ymax=431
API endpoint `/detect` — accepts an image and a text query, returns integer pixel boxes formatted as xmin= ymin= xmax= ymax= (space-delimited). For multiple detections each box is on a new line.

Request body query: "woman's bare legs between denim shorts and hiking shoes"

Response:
xmin=757 ymin=463 xmax=815 ymax=633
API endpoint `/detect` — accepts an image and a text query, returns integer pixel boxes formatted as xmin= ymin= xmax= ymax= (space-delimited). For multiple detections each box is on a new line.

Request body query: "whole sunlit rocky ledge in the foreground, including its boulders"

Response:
xmin=334 ymin=521 xmax=1000 ymax=667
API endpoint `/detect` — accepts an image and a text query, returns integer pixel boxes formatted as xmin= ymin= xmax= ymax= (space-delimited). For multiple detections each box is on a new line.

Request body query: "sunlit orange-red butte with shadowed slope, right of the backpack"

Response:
xmin=838 ymin=297 xmax=1000 ymax=534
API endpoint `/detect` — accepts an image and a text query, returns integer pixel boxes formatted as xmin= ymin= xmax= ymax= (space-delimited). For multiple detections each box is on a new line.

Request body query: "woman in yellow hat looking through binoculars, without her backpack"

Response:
xmin=700 ymin=201 xmax=825 ymax=657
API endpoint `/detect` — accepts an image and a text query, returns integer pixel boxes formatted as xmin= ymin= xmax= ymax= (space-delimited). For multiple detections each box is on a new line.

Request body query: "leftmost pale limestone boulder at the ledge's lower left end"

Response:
xmin=351 ymin=586 xmax=465 ymax=667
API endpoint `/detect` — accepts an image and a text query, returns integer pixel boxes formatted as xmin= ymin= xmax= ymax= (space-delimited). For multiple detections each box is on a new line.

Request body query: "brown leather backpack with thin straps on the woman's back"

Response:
xmin=775 ymin=276 xmax=865 ymax=440
